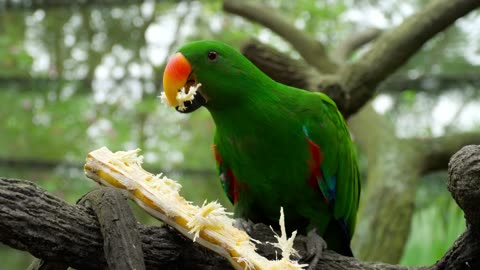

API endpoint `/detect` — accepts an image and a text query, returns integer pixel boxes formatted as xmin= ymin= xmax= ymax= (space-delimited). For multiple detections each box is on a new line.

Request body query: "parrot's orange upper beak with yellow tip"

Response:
xmin=163 ymin=52 xmax=192 ymax=106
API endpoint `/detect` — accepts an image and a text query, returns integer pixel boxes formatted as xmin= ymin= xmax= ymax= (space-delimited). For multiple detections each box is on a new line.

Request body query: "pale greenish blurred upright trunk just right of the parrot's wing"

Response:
xmin=349 ymin=105 xmax=422 ymax=263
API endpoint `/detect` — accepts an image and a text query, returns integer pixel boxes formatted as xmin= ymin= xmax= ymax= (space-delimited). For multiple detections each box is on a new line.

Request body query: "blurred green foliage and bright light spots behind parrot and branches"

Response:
xmin=0 ymin=0 xmax=480 ymax=269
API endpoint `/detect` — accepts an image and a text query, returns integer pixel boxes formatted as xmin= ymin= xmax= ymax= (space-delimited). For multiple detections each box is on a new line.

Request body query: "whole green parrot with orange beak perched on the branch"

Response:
xmin=163 ymin=41 xmax=360 ymax=256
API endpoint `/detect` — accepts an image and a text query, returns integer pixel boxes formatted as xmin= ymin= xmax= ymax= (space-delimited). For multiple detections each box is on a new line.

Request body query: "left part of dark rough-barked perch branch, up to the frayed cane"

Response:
xmin=0 ymin=178 xmax=229 ymax=269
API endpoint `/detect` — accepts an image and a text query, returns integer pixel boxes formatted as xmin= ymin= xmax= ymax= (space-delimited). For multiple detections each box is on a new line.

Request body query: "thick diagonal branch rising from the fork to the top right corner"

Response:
xmin=339 ymin=0 xmax=480 ymax=115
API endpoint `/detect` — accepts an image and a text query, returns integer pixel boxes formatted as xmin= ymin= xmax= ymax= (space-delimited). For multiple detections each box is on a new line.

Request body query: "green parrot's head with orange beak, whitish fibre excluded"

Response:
xmin=163 ymin=41 xmax=270 ymax=113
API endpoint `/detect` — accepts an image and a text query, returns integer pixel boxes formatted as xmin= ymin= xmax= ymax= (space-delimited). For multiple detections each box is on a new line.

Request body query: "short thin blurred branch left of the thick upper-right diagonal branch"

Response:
xmin=332 ymin=28 xmax=383 ymax=63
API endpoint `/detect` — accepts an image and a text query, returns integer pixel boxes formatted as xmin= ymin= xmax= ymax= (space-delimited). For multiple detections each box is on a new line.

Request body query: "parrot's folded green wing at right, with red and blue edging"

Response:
xmin=304 ymin=93 xmax=360 ymax=239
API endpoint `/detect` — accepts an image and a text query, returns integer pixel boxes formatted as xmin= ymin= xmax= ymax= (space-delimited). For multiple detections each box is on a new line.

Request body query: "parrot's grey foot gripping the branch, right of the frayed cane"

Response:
xmin=297 ymin=229 xmax=327 ymax=270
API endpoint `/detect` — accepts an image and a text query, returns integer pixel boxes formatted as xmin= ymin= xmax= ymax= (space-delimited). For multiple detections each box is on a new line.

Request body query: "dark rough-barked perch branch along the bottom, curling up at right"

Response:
xmin=0 ymin=146 xmax=480 ymax=270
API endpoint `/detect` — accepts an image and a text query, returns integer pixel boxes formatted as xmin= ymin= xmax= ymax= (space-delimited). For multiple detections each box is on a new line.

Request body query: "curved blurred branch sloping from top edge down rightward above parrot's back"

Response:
xmin=223 ymin=0 xmax=337 ymax=73
